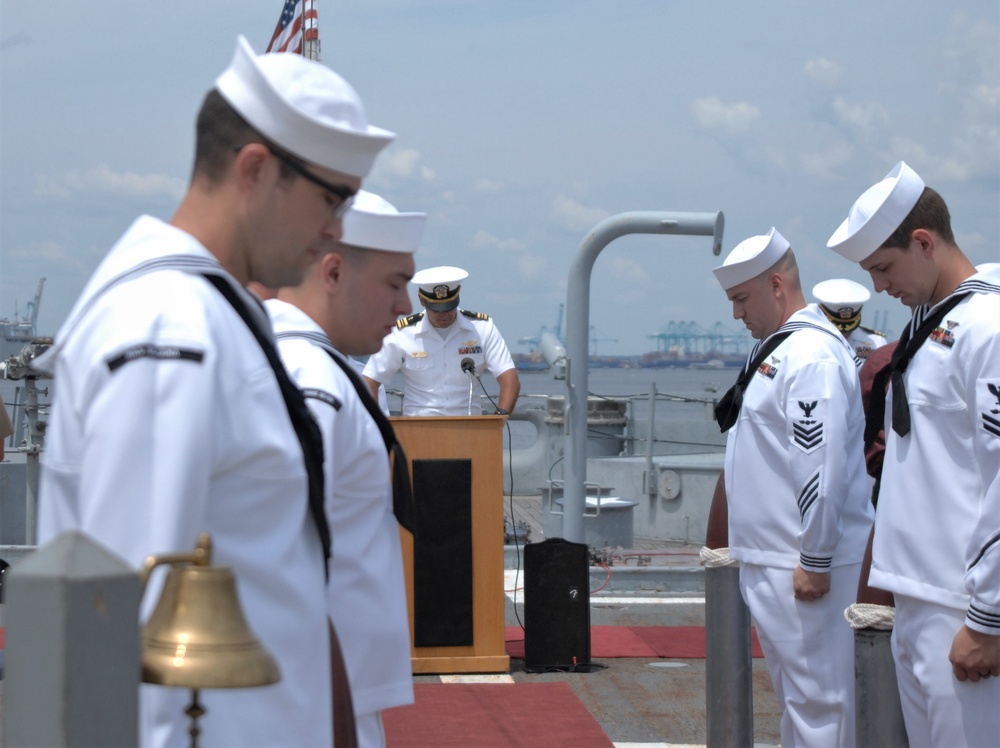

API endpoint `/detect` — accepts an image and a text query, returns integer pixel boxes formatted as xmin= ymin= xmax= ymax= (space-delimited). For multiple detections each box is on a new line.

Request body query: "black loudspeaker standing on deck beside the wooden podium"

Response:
xmin=524 ymin=538 xmax=590 ymax=672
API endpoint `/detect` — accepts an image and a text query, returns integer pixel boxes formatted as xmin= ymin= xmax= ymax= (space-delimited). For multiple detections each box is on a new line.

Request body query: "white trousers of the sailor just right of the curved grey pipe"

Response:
xmin=740 ymin=564 xmax=861 ymax=748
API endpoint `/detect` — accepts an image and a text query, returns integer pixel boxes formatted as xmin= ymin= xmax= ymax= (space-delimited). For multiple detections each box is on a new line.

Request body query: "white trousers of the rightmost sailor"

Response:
xmin=891 ymin=594 xmax=1000 ymax=748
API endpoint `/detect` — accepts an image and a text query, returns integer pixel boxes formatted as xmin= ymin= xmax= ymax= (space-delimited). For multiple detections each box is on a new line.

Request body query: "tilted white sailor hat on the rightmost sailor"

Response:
xmin=826 ymin=161 xmax=924 ymax=262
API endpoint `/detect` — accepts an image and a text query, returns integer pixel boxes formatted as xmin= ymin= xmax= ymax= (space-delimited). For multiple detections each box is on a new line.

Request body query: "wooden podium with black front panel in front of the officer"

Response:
xmin=390 ymin=416 xmax=510 ymax=674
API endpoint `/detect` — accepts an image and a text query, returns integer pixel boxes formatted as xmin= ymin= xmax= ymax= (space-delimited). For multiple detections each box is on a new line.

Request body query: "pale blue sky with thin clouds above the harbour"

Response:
xmin=0 ymin=0 xmax=1000 ymax=354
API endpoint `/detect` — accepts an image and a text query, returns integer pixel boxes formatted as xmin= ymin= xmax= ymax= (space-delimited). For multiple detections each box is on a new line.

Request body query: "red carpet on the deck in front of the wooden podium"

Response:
xmin=382 ymin=682 xmax=613 ymax=748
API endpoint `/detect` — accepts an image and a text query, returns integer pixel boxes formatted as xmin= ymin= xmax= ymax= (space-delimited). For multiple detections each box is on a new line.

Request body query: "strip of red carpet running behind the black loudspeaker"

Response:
xmin=504 ymin=626 xmax=764 ymax=660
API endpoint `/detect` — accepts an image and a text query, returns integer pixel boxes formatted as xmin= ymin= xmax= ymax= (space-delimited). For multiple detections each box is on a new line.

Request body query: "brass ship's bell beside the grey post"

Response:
xmin=142 ymin=533 xmax=281 ymax=689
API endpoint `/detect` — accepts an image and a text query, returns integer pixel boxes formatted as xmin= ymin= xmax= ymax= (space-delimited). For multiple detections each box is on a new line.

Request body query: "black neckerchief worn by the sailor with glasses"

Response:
xmin=204 ymin=273 xmax=331 ymax=578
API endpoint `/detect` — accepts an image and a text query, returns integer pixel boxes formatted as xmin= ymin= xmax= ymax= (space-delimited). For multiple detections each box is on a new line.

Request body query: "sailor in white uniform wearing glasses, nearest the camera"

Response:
xmin=38 ymin=37 xmax=392 ymax=748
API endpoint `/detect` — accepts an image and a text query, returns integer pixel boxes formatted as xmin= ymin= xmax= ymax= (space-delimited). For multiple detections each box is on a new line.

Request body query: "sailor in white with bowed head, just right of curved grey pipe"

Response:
xmin=714 ymin=228 xmax=873 ymax=746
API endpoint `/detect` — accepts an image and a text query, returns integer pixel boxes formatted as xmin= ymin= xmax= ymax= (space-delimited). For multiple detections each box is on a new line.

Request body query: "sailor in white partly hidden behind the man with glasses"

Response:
xmin=266 ymin=190 xmax=426 ymax=748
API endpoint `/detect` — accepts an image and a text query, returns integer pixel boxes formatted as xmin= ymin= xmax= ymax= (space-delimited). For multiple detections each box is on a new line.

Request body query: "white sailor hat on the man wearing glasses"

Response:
xmin=215 ymin=36 xmax=396 ymax=177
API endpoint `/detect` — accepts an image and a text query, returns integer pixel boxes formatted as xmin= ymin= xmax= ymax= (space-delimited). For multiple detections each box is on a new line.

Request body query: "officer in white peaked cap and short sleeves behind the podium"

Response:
xmin=364 ymin=266 xmax=521 ymax=416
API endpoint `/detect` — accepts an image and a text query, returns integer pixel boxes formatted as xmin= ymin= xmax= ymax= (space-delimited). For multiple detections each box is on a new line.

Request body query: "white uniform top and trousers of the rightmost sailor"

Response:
xmin=870 ymin=265 xmax=1000 ymax=745
